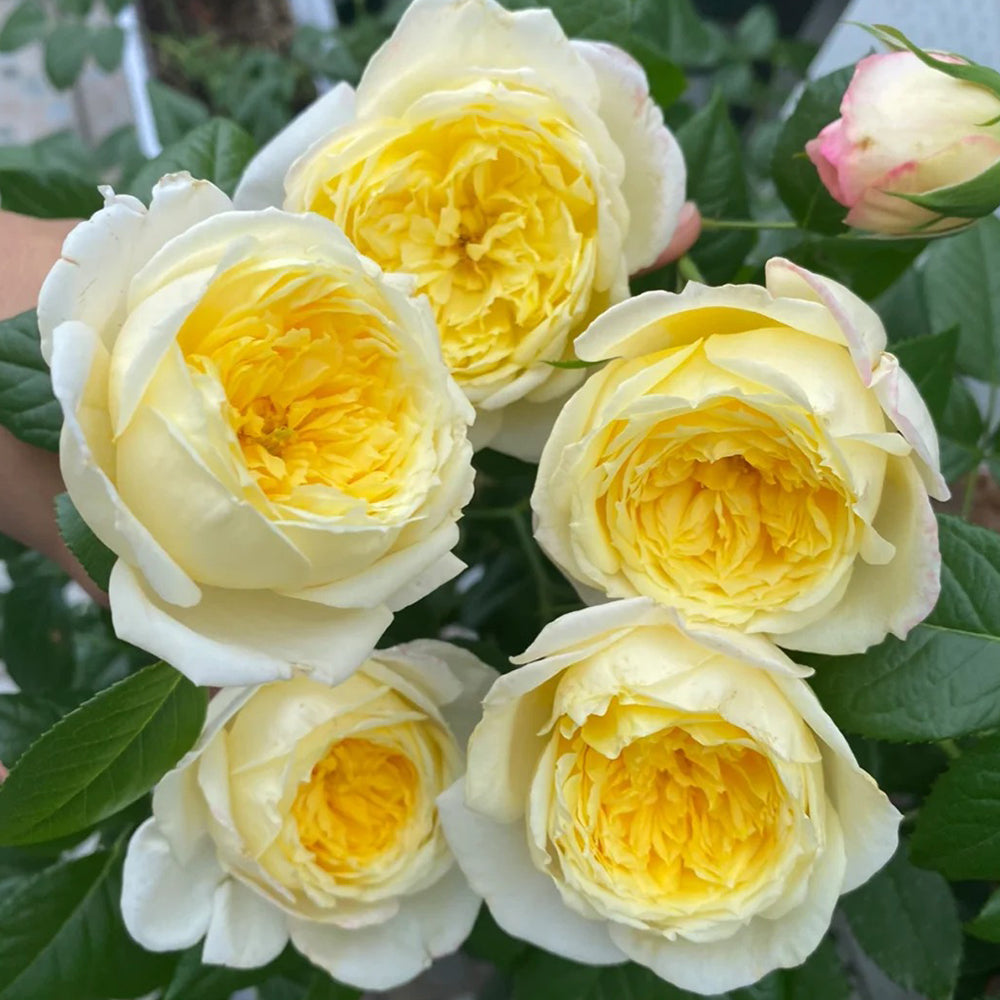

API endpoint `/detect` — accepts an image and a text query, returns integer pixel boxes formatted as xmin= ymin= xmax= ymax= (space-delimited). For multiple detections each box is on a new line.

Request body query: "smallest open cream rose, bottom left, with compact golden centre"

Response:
xmin=122 ymin=640 xmax=496 ymax=990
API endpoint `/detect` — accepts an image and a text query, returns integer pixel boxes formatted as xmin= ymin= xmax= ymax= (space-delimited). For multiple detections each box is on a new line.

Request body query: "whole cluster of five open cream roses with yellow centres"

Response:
xmin=39 ymin=0 xmax=992 ymax=992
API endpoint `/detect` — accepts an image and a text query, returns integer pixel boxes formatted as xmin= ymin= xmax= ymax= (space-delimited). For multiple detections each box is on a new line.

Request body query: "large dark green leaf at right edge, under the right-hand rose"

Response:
xmin=800 ymin=516 xmax=1000 ymax=741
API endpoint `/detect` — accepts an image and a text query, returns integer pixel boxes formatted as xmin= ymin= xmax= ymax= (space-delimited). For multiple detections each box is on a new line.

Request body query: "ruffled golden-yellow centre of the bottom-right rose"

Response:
xmin=553 ymin=717 xmax=791 ymax=914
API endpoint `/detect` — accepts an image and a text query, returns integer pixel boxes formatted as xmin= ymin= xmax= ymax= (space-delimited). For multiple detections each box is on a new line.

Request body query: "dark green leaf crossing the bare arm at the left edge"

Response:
xmin=0 ymin=309 xmax=62 ymax=451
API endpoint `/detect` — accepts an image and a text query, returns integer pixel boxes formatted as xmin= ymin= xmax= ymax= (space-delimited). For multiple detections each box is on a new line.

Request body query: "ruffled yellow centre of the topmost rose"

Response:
xmin=286 ymin=96 xmax=597 ymax=401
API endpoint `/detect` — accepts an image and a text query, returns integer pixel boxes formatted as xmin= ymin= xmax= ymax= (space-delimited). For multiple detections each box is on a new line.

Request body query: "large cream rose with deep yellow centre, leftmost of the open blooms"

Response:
xmin=38 ymin=174 xmax=473 ymax=685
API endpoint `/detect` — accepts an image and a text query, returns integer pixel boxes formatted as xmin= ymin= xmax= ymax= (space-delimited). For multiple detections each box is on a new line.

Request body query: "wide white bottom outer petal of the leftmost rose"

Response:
xmin=108 ymin=560 xmax=392 ymax=686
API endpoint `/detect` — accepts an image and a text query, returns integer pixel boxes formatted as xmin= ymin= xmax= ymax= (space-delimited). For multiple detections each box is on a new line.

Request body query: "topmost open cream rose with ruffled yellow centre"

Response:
xmin=235 ymin=0 xmax=685 ymax=459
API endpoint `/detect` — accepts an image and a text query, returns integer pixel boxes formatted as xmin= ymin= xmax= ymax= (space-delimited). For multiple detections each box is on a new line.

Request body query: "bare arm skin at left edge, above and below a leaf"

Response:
xmin=0 ymin=211 xmax=107 ymax=604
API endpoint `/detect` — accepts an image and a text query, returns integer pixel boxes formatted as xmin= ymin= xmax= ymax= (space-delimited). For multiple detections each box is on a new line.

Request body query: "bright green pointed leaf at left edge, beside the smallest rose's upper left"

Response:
xmin=0 ymin=663 xmax=206 ymax=845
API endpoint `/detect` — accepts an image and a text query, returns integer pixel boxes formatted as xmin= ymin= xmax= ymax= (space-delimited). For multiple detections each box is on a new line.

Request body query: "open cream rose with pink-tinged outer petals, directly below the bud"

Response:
xmin=531 ymin=259 xmax=948 ymax=653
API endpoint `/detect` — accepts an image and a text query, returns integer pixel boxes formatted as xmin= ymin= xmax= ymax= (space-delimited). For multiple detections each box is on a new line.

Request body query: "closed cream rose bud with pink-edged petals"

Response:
xmin=806 ymin=51 xmax=1000 ymax=236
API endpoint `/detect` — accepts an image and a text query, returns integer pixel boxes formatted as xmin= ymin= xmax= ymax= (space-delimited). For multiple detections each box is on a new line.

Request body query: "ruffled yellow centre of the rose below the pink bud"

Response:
xmin=598 ymin=398 xmax=860 ymax=623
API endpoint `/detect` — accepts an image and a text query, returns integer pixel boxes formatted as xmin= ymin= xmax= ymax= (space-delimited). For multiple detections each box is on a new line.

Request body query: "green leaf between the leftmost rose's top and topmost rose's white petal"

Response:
xmin=129 ymin=118 xmax=255 ymax=202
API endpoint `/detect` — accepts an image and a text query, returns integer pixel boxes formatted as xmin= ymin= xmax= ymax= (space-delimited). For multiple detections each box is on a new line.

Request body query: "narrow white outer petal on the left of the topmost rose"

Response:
xmin=233 ymin=83 xmax=354 ymax=210
